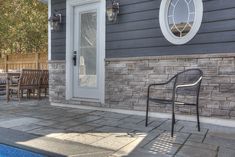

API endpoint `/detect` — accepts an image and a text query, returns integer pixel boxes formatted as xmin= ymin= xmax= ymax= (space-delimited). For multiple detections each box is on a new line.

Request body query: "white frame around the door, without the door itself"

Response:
xmin=66 ymin=0 xmax=106 ymax=103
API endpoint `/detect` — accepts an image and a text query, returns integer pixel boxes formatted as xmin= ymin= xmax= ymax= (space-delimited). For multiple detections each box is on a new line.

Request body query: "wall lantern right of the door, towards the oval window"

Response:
xmin=106 ymin=0 xmax=119 ymax=22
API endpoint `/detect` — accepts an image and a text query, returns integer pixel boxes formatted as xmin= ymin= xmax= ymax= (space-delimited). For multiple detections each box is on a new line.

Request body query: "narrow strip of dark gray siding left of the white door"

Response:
xmin=51 ymin=0 xmax=66 ymax=60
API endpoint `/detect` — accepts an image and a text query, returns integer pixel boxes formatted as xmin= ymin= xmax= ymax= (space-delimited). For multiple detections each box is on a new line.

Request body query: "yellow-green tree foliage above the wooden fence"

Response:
xmin=0 ymin=0 xmax=48 ymax=54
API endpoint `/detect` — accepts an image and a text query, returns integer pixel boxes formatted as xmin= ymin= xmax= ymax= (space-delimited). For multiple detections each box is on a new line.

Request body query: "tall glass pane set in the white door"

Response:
xmin=79 ymin=11 xmax=97 ymax=88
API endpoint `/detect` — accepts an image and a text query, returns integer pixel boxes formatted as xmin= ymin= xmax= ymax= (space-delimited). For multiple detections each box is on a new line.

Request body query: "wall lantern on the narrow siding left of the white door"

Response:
xmin=48 ymin=13 xmax=62 ymax=31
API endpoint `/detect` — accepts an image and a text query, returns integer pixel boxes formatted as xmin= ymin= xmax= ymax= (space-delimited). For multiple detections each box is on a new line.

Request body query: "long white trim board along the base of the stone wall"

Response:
xmin=51 ymin=102 xmax=235 ymax=128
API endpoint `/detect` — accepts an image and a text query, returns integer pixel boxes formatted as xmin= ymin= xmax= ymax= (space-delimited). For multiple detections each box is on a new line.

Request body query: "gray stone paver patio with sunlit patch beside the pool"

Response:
xmin=0 ymin=99 xmax=235 ymax=157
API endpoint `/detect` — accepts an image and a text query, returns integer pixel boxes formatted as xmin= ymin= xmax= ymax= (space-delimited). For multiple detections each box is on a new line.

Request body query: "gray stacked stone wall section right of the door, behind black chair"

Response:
xmin=105 ymin=54 xmax=235 ymax=119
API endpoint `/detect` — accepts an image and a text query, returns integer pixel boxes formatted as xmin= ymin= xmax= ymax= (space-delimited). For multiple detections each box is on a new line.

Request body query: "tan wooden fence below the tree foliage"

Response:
xmin=0 ymin=53 xmax=48 ymax=72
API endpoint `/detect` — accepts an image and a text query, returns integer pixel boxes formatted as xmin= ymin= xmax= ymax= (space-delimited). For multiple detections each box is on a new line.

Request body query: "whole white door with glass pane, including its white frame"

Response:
xmin=66 ymin=0 xmax=106 ymax=103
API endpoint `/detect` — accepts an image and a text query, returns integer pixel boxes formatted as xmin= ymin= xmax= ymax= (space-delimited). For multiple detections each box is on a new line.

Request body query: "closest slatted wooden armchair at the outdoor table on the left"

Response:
xmin=7 ymin=69 xmax=42 ymax=101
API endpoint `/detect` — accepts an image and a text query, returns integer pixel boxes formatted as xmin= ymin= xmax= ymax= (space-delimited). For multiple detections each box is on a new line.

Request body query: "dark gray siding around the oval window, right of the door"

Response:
xmin=106 ymin=0 xmax=235 ymax=58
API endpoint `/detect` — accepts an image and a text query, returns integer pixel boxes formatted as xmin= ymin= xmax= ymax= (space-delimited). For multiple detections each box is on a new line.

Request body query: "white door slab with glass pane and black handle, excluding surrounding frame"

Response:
xmin=71 ymin=2 xmax=104 ymax=102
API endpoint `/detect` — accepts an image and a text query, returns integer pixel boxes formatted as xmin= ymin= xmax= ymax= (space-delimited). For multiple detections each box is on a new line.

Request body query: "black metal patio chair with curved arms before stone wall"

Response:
xmin=145 ymin=69 xmax=203 ymax=137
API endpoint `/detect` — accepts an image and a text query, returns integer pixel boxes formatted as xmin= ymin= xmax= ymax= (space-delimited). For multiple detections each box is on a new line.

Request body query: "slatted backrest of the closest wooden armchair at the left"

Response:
xmin=19 ymin=69 xmax=42 ymax=86
